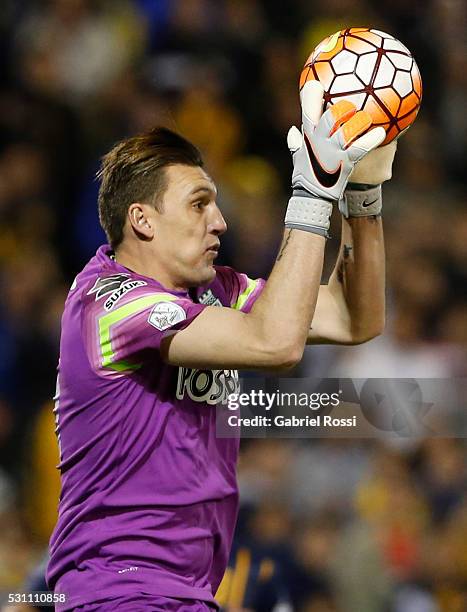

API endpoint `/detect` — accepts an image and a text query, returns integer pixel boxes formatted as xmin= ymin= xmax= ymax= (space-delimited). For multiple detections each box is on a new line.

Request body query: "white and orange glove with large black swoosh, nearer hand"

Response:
xmin=285 ymin=81 xmax=386 ymax=236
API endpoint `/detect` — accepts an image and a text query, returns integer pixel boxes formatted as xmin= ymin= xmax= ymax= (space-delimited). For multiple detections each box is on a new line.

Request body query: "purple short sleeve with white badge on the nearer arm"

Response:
xmin=81 ymin=283 xmax=205 ymax=373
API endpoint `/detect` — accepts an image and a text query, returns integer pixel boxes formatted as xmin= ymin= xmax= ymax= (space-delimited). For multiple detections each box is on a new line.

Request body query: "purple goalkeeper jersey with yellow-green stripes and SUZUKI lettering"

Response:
xmin=47 ymin=246 xmax=264 ymax=610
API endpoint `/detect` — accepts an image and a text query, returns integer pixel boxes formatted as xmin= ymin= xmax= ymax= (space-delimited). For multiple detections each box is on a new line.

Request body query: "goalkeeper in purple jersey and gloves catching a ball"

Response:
xmin=47 ymin=82 xmax=393 ymax=612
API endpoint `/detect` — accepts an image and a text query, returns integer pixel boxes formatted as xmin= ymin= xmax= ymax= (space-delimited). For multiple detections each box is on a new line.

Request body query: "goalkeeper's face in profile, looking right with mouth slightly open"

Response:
xmin=153 ymin=165 xmax=227 ymax=288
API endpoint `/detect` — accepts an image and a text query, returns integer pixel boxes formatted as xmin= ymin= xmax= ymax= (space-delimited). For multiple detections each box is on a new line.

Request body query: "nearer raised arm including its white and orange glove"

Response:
xmin=161 ymin=81 xmax=385 ymax=369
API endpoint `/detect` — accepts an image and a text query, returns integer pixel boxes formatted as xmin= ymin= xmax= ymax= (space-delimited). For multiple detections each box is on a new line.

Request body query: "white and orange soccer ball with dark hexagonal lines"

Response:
xmin=300 ymin=28 xmax=422 ymax=145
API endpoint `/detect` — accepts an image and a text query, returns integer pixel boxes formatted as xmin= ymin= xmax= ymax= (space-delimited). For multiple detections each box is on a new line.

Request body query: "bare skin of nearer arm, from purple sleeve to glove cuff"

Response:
xmin=162 ymin=229 xmax=325 ymax=369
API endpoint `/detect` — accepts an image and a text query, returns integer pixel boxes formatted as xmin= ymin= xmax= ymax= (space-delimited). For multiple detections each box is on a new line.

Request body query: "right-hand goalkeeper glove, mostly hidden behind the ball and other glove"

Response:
xmin=339 ymin=140 xmax=397 ymax=218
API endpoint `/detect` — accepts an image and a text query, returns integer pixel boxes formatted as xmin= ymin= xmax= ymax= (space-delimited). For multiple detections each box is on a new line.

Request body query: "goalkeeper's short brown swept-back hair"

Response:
xmin=97 ymin=127 xmax=203 ymax=249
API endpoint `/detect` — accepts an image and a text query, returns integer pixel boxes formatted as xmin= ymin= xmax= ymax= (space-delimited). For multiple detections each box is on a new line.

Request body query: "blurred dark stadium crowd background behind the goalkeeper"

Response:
xmin=0 ymin=0 xmax=467 ymax=612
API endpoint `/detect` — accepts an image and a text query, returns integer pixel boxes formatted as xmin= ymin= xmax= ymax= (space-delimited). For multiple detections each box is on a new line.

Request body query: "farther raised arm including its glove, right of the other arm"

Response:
xmin=308 ymin=142 xmax=396 ymax=344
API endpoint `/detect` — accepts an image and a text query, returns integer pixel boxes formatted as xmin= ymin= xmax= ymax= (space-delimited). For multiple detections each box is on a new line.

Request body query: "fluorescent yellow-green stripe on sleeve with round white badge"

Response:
xmin=99 ymin=293 xmax=177 ymax=372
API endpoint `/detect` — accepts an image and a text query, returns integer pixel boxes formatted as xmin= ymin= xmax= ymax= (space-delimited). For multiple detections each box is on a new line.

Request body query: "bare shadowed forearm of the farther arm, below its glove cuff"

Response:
xmin=328 ymin=216 xmax=385 ymax=342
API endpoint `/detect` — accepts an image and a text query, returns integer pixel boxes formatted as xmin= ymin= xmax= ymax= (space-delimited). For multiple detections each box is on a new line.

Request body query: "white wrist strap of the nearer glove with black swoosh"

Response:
xmin=285 ymin=189 xmax=332 ymax=238
